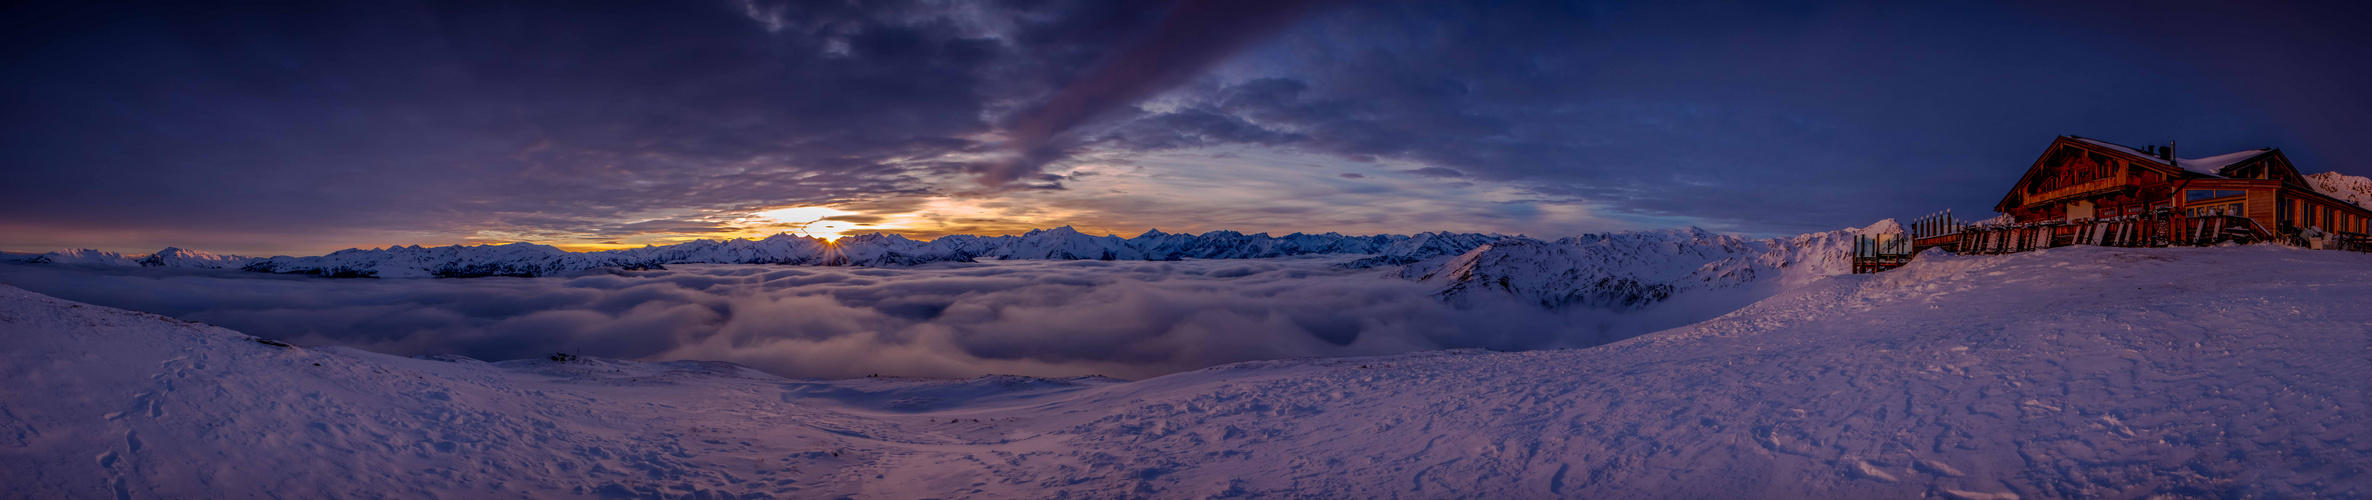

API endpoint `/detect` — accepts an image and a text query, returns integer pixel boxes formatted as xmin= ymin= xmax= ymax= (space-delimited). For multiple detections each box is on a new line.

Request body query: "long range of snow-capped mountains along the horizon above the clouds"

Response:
xmin=9 ymin=218 xmax=1902 ymax=310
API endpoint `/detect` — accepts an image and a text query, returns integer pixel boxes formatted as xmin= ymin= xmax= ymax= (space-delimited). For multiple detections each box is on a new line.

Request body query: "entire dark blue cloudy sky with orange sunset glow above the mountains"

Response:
xmin=0 ymin=0 xmax=2372 ymax=254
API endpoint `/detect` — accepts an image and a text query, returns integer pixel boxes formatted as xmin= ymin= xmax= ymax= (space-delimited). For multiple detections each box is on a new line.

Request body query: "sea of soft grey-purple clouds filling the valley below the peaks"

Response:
xmin=0 ymin=256 xmax=1717 ymax=379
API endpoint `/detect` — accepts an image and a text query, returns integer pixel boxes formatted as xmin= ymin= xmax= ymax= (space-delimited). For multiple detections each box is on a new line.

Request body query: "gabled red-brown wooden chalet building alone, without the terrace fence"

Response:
xmin=1992 ymin=135 xmax=2372 ymax=237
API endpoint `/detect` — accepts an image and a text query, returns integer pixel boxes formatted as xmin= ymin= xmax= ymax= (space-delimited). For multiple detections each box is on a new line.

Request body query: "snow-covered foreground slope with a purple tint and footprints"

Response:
xmin=0 ymin=246 xmax=2372 ymax=498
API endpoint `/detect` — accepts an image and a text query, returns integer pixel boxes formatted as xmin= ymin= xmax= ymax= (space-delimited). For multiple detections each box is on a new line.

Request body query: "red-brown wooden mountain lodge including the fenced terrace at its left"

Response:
xmin=1853 ymin=135 xmax=2372 ymax=273
